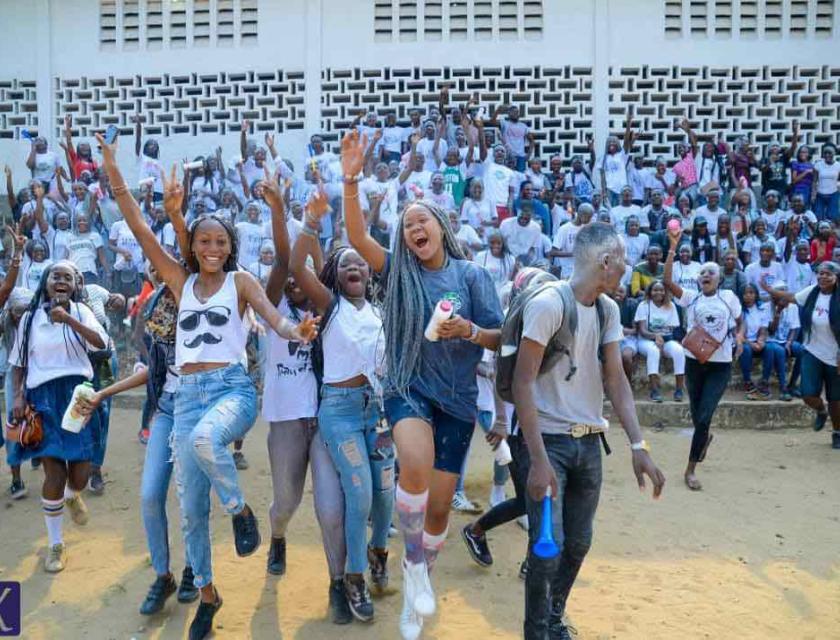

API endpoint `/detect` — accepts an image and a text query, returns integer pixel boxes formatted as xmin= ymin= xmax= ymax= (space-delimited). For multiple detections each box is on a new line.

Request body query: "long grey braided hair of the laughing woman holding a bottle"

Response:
xmin=383 ymin=200 xmax=465 ymax=404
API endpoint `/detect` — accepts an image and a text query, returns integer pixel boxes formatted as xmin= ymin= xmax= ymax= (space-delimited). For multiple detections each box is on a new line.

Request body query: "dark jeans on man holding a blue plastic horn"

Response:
xmin=524 ymin=434 xmax=601 ymax=640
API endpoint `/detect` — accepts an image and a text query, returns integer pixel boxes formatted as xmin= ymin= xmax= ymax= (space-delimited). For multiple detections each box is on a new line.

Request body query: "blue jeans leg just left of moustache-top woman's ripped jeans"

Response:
xmin=140 ymin=393 xmax=189 ymax=576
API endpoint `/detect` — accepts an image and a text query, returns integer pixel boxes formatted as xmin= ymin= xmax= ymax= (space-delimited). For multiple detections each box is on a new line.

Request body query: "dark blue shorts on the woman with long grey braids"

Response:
xmin=385 ymin=390 xmax=475 ymax=474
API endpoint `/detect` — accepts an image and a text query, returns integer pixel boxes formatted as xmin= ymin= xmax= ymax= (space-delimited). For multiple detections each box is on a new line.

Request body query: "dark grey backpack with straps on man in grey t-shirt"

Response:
xmin=496 ymin=281 xmax=605 ymax=402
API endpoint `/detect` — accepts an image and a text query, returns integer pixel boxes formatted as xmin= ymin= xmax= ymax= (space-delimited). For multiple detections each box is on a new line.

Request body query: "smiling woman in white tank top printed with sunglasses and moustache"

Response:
xmin=97 ymin=141 xmax=318 ymax=638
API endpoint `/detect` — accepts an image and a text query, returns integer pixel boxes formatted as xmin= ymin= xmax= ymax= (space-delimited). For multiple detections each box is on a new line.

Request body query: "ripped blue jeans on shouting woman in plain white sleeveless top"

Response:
xmin=318 ymin=384 xmax=394 ymax=573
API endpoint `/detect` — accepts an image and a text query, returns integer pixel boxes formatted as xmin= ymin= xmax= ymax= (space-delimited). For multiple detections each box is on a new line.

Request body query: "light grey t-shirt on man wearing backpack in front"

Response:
xmin=522 ymin=291 xmax=622 ymax=433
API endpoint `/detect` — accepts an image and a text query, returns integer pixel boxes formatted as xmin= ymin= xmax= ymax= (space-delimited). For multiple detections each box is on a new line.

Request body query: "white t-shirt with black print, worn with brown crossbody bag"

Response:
xmin=677 ymin=289 xmax=741 ymax=362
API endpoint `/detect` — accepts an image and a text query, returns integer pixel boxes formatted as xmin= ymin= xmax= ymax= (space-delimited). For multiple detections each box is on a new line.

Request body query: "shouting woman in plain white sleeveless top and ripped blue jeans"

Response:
xmin=290 ymin=191 xmax=394 ymax=622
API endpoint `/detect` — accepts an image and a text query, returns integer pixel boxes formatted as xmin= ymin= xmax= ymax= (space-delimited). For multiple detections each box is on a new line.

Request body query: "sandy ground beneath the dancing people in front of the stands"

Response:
xmin=0 ymin=411 xmax=840 ymax=640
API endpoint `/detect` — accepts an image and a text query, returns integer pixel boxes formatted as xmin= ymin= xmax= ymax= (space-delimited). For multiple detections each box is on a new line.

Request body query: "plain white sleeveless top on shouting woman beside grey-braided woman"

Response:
xmin=323 ymin=296 xmax=385 ymax=389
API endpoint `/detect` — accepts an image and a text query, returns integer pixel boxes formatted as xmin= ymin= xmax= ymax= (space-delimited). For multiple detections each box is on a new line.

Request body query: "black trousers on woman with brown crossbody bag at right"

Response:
xmin=685 ymin=358 xmax=732 ymax=462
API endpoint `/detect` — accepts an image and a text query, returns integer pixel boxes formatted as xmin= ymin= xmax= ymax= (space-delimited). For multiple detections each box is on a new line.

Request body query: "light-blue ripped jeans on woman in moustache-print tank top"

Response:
xmin=172 ymin=364 xmax=257 ymax=587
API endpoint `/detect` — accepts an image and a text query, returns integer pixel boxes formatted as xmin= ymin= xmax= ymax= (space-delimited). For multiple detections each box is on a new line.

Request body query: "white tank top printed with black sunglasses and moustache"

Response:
xmin=175 ymin=271 xmax=248 ymax=368
